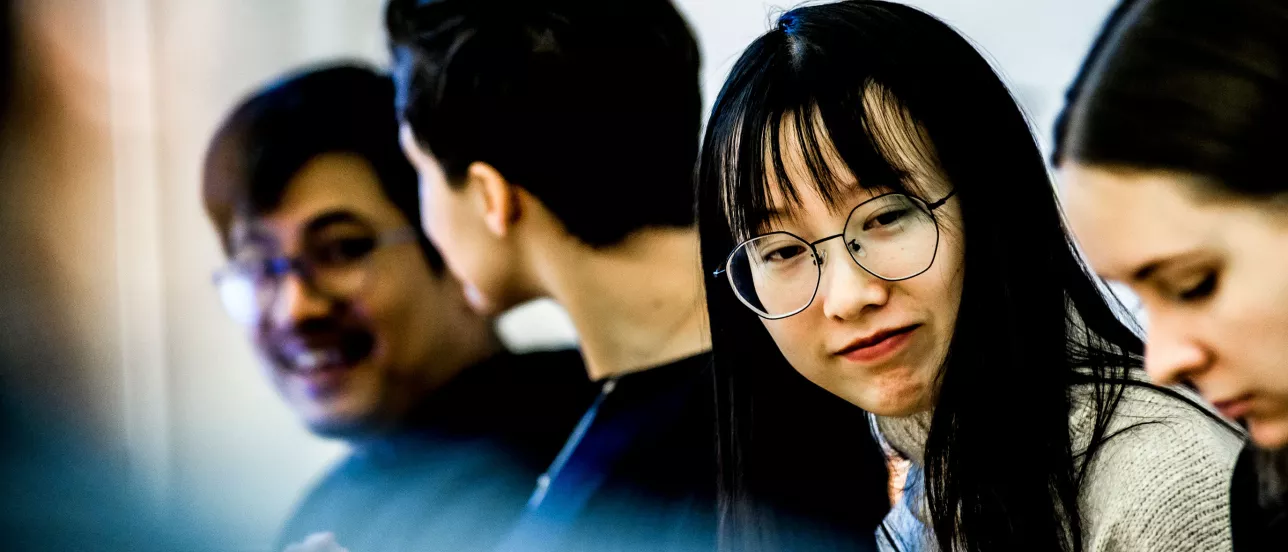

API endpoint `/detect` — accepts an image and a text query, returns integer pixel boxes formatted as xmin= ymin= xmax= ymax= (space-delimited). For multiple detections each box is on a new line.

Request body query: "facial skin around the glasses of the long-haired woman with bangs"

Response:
xmin=747 ymin=119 xmax=963 ymax=416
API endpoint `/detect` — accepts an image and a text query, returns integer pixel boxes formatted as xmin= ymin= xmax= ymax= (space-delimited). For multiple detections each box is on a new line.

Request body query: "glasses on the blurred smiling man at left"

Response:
xmin=214 ymin=224 xmax=419 ymax=326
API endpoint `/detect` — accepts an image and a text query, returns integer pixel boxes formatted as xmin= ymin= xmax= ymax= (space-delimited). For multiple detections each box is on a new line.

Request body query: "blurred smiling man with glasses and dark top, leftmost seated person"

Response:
xmin=204 ymin=66 xmax=591 ymax=551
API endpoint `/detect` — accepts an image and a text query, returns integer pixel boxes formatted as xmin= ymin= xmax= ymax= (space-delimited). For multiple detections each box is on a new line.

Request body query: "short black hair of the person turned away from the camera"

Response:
xmin=386 ymin=0 xmax=702 ymax=246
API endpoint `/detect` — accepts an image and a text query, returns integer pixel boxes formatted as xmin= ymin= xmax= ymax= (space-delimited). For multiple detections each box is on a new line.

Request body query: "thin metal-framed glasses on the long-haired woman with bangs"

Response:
xmin=715 ymin=190 xmax=957 ymax=320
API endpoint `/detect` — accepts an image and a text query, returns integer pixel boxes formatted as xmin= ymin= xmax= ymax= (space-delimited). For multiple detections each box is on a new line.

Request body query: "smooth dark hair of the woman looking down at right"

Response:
xmin=1055 ymin=0 xmax=1288 ymax=198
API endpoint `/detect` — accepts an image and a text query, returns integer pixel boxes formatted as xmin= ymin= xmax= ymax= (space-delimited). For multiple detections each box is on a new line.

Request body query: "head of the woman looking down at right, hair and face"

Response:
xmin=1055 ymin=0 xmax=1288 ymax=448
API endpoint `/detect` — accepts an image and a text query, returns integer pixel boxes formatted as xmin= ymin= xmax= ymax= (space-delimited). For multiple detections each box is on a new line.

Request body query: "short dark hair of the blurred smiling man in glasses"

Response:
xmin=202 ymin=63 xmax=443 ymax=270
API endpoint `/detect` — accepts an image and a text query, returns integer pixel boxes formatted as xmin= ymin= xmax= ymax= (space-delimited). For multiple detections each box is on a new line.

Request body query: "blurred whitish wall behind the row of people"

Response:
xmin=28 ymin=0 xmax=1112 ymax=551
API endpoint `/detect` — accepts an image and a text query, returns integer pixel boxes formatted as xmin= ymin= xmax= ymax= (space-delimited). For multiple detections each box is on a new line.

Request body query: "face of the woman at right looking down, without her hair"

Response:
xmin=1061 ymin=163 xmax=1288 ymax=448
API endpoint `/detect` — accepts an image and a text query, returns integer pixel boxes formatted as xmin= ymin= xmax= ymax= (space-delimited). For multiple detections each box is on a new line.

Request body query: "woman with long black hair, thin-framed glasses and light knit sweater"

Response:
xmin=698 ymin=1 xmax=1240 ymax=552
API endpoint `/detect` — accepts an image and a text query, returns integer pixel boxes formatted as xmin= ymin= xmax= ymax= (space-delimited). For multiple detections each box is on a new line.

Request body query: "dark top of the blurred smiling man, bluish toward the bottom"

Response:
xmin=277 ymin=351 xmax=595 ymax=552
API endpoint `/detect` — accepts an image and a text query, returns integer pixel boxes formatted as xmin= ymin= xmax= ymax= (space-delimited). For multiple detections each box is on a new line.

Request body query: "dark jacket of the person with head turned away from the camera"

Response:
xmin=498 ymin=354 xmax=886 ymax=552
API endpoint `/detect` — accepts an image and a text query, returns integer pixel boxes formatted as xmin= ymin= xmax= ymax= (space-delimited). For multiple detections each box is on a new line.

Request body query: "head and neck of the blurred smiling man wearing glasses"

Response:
xmin=204 ymin=66 xmax=497 ymax=437
